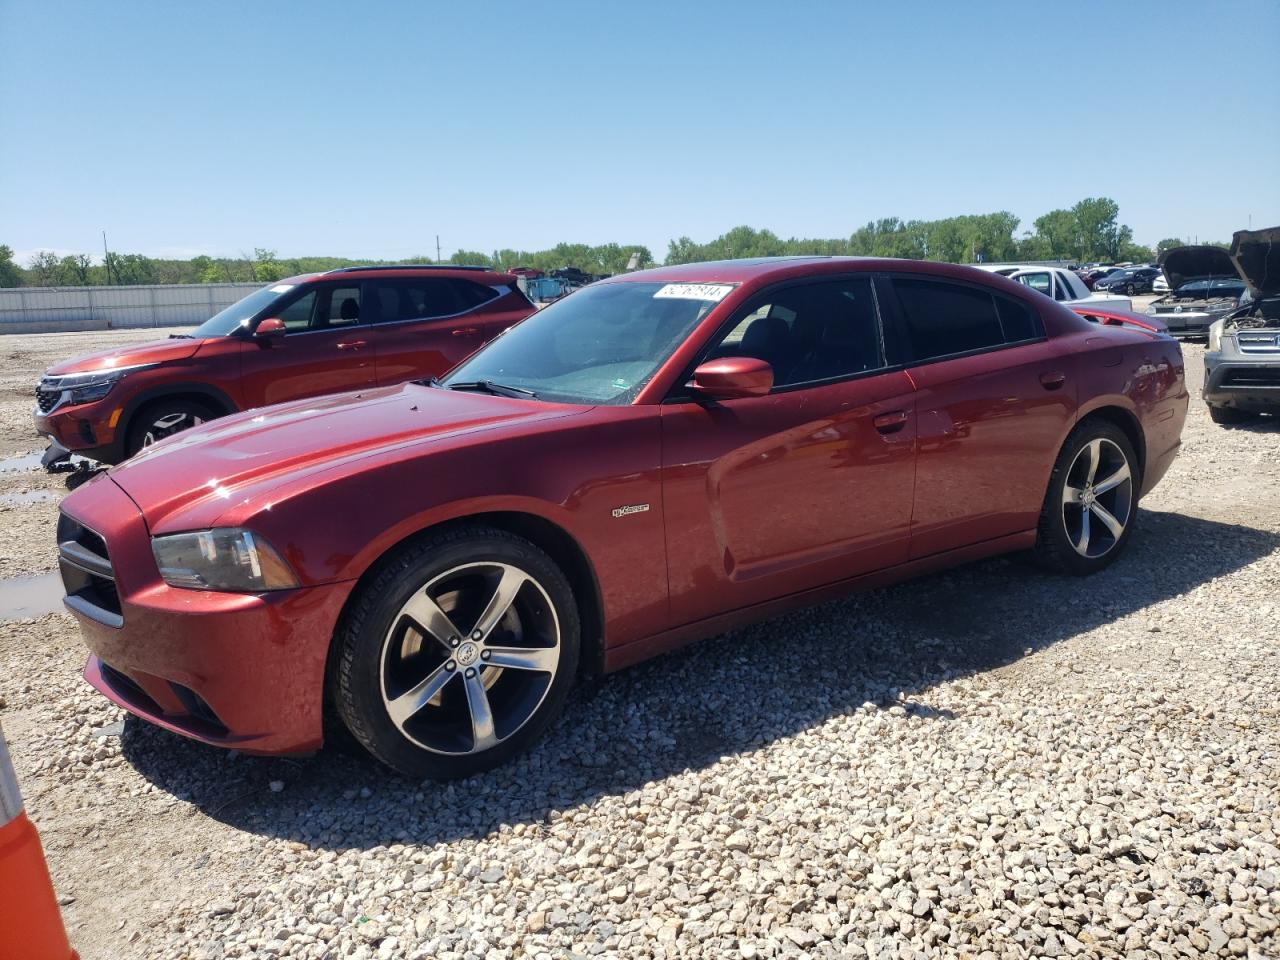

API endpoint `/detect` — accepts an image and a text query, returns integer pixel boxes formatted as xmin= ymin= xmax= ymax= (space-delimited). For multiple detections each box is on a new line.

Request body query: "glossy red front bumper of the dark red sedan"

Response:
xmin=59 ymin=476 xmax=353 ymax=754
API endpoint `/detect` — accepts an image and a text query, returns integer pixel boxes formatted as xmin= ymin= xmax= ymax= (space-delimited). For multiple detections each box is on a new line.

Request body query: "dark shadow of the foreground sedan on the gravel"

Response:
xmin=123 ymin=511 xmax=1280 ymax=850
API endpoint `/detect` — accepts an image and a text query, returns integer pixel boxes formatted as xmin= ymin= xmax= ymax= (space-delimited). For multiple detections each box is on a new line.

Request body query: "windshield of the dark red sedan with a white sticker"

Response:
xmin=444 ymin=282 xmax=732 ymax=404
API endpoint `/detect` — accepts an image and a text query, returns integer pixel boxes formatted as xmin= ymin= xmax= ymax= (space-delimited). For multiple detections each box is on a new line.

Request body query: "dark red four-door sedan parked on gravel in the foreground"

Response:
xmin=58 ymin=257 xmax=1188 ymax=777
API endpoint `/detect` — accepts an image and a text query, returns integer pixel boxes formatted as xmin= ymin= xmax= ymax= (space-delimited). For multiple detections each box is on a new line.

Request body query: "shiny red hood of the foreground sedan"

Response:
xmin=110 ymin=384 xmax=590 ymax=532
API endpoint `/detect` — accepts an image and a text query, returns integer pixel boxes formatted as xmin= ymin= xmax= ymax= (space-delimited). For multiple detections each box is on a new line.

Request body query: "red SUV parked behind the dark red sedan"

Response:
xmin=35 ymin=265 xmax=534 ymax=466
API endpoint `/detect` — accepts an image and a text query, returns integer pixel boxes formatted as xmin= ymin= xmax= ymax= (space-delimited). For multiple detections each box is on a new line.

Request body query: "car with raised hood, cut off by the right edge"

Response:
xmin=1203 ymin=227 xmax=1280 ymax=424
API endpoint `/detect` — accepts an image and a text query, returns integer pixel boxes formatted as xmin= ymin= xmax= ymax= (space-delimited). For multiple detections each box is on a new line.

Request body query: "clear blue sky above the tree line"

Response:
xmin=0 ymin=0 xmax=1280 ymax=260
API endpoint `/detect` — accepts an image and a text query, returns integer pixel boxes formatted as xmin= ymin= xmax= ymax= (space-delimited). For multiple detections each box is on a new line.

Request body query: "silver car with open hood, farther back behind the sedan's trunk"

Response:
xmin=1147 ymin=244 xmax=1249 ymax=337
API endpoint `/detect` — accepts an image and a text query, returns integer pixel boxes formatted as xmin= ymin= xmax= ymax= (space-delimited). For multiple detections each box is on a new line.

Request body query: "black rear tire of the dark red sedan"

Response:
xmin=1033 ymin=419 xmax=1142 ymax=576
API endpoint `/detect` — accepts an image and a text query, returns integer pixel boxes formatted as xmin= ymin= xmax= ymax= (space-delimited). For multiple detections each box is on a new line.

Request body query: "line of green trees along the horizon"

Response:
xmin=0 ymin=197 xmax=1213 ymax=287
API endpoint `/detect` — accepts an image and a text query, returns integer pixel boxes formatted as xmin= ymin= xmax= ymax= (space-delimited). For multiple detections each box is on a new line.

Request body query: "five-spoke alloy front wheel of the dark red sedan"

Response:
xmin=380 ymin=562 xmax=561 ymax=755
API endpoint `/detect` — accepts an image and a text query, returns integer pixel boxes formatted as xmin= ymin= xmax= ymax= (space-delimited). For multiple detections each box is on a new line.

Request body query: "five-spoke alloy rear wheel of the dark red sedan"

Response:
xmin=1062 ymin=436 xmax=1133 ymax=559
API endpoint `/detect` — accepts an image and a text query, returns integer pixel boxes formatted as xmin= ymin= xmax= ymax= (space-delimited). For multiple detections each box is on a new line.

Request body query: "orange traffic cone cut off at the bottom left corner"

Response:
xmin=0 ymin=727 xmax=76 ymax=960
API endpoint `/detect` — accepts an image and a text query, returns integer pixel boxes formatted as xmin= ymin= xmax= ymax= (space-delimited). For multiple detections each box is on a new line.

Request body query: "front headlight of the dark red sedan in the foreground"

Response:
xmin=151 ymin=527 xmax=298 ymax=594
